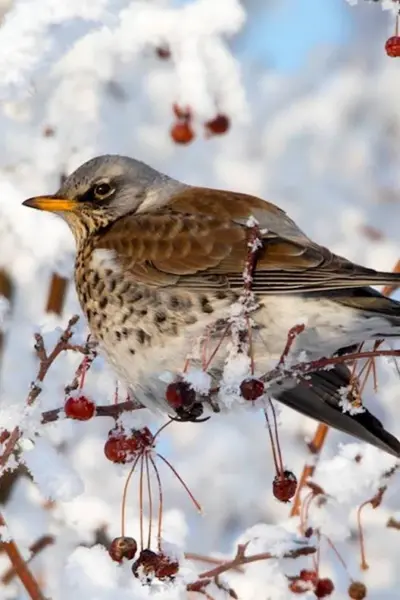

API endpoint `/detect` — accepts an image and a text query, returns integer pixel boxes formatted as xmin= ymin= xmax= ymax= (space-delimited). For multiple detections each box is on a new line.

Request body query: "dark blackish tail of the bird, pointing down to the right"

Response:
xmin=276 ymin=365 xmax=400 ymax=458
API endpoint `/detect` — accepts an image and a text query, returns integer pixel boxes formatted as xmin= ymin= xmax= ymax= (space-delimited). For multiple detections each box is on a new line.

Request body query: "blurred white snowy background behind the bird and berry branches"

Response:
xmin=0 ymin=0 xmax=400 ymax=600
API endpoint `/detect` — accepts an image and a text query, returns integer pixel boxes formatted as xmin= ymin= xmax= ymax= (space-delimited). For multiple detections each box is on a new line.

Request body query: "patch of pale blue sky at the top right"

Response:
xmin=240 ymin=0 xmax=354 ymax=71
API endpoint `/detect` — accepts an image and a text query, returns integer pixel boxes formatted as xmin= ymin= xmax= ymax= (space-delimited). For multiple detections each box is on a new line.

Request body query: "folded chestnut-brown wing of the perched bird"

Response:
xmin=95 ymin=188 xmax=399 ymax=294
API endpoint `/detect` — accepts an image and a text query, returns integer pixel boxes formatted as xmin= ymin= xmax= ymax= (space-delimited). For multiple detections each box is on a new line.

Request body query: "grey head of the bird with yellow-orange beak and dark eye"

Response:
xmin=24 ymin=155 xmax=186 ymax=243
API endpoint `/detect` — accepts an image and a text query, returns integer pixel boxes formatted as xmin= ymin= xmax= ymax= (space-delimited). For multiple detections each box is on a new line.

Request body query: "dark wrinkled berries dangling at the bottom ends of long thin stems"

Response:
xmin=108 ymin=536 xmax=179 ymax=583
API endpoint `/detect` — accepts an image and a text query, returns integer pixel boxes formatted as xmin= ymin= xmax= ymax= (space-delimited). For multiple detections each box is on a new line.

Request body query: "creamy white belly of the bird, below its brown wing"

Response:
xmin=97 ymin=296 xmax=394 ymax=410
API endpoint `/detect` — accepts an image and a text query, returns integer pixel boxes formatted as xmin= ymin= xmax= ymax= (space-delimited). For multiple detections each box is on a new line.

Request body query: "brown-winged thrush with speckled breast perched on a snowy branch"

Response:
xmin=23 ymin=155 xmax=400 ymax=457
